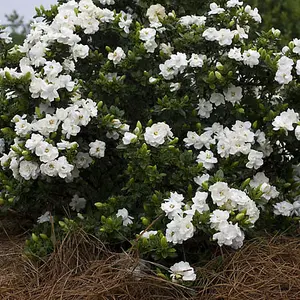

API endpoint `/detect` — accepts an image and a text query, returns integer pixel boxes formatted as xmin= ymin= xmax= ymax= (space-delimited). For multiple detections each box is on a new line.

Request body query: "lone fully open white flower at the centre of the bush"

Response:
xmin=144 ymin=122 xmax=173 ymax=147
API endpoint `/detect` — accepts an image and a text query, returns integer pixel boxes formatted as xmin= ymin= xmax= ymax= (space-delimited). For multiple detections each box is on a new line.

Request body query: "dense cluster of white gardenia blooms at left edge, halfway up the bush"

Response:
xmin=0 ymin=99 xmax=105 ymax=180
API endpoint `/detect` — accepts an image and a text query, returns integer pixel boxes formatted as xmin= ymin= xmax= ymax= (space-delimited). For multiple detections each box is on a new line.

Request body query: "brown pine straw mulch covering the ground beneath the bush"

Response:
xmin=0 ymin=226 xmax=300 ymax=300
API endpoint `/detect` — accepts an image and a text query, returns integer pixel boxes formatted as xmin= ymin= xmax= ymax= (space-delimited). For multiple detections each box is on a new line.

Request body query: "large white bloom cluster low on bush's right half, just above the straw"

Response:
xmin=161 ymin=180 xmax=260 ymax=249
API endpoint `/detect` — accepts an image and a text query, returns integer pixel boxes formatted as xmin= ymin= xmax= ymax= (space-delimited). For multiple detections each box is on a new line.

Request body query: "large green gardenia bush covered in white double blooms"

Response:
xmin=0 ymin=0 xmax=300 ymax=282
